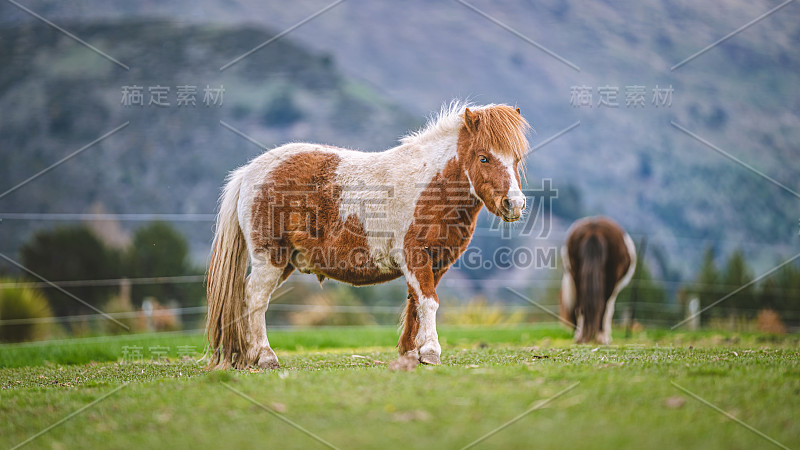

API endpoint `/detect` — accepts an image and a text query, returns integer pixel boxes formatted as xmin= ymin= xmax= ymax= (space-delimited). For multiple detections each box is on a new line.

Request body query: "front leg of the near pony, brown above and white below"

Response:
xmin=404 ymin=262 xmax=442 ymax=365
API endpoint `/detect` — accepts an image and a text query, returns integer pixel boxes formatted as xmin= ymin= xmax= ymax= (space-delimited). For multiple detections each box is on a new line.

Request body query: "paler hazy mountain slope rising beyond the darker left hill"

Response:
xmin=0 ymin=0 xmax=800 ymax=282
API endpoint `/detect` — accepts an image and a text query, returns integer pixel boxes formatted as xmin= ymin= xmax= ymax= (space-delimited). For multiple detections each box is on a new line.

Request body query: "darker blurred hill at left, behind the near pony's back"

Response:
xmin=0 ymin=22 xmax=422 ymax=255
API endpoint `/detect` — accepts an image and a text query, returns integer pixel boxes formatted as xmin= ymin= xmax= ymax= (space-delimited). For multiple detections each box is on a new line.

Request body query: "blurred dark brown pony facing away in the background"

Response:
xmin=559 ymin=217 xmax=636 ymax=344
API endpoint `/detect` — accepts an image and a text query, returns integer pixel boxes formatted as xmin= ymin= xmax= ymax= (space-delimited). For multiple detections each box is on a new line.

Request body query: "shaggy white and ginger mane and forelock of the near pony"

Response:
xmin=400 ymin=101 xmax=531 ymax=160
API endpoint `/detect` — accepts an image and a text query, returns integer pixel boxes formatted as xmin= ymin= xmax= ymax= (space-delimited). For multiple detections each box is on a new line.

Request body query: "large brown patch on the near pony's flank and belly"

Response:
xmin=250 ymin=151 xmax=401 ymax=285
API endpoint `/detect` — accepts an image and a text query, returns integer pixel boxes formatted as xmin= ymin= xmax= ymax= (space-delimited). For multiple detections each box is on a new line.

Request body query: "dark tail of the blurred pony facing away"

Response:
xmin=577 ymin=235 xmax=607 ymax=342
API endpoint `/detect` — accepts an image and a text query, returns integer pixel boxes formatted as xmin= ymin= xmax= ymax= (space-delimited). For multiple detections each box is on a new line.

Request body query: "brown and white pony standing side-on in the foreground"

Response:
xmin=206 ymin=103 xmax=529 ymax=368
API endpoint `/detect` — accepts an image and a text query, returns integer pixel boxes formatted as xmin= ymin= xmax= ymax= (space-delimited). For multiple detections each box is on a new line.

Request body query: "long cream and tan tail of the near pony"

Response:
xmin=206 ymin=169 xmax=247 ymax=369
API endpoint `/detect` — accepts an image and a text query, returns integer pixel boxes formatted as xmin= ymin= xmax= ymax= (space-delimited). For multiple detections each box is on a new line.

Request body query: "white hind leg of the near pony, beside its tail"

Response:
xmin=245 ymin=259 xmax=291 ymax=369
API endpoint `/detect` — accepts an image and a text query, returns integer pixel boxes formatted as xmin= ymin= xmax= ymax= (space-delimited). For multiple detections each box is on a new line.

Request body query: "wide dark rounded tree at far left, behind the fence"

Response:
xmin=20 ymin=226 xmax=121 ymax=316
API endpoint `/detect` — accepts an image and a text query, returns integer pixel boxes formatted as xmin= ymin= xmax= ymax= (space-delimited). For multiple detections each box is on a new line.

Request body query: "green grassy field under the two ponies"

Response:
xmin=0 ymin=326 xmax=800 ymax=448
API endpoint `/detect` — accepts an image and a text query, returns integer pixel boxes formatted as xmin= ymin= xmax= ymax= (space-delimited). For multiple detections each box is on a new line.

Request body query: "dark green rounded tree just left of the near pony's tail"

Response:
xmin=125 ymin=222 xmax=203 ymax=306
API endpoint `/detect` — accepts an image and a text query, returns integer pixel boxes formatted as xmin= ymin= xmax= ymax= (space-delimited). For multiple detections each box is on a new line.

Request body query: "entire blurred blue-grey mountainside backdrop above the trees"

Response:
xmin=0 ymin=0 xmax=800 ymax=288
